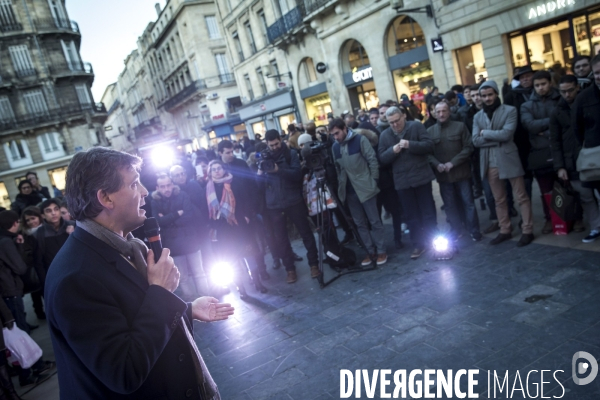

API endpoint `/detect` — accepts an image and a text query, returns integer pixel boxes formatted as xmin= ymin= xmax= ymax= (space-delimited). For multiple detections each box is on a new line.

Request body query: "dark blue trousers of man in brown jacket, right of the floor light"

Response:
xmin=439 ymin=179 xmax=479 ymax=234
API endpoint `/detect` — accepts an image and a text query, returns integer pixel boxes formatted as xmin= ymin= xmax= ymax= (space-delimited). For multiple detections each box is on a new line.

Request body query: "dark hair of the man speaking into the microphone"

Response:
xmin=65 ymin=147 xmax=142 ymax=221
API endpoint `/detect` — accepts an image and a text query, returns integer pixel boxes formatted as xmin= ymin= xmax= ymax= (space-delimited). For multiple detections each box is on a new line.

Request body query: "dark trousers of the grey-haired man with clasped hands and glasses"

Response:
xmin=398 ymin=182 xmax=437 ymax=248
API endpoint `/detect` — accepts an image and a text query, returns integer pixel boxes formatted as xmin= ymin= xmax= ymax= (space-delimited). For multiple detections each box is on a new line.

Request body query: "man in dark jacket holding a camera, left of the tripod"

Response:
xmin=257 ymin=129 xmax=321 ymax=283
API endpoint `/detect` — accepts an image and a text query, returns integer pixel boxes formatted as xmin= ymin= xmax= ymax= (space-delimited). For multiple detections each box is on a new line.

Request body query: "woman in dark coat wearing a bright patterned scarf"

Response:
xmin=206 ymin=160 xmax=267 ymax=299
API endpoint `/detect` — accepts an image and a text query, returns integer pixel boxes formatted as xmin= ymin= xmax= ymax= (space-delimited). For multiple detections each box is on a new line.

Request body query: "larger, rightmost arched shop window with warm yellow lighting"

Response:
xmin=386 ymin=15 xmax=434 ymax=108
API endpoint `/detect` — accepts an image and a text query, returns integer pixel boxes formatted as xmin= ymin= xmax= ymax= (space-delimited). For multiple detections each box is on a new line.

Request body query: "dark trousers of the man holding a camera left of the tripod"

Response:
xmin=266 ymin=202 xmax=319 ymax=271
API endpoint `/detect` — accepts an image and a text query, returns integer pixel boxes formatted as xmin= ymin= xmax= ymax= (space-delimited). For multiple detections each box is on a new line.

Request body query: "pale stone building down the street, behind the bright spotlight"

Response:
xmin=105 ymin=0 xmax=245 ymax=156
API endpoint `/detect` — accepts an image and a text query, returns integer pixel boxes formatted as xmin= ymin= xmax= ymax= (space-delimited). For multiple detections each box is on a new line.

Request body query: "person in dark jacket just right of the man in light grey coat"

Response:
xmin=521 ymin=71 xmax=560 ymax=234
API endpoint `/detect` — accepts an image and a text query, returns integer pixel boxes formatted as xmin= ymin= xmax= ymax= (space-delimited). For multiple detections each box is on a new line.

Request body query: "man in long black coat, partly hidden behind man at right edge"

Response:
xmin=550 ymin=75 xmax=600 ymax=243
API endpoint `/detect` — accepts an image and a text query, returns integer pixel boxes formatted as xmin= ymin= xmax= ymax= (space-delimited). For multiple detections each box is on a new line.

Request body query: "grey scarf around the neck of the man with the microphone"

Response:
xmin=76 ymin=219 xmax=148 ymax=280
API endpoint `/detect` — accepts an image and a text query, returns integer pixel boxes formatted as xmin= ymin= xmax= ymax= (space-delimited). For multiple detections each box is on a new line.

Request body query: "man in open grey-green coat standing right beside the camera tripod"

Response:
xmin=329 ymin=118 xmax=387 ymax=266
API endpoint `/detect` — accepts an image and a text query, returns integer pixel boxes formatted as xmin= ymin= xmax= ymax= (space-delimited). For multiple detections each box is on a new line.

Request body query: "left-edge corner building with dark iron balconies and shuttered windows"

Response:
xmin=0 ymin=0 xmax=108 ymax=208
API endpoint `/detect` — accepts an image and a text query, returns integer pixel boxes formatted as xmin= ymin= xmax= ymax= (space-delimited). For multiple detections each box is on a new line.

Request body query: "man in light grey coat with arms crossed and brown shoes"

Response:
xmin=473 ymin=80 xmax=533 ymax=247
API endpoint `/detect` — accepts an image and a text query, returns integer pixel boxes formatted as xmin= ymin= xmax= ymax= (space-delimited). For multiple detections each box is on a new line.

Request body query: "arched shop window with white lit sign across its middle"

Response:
xmin=341 ymin=39 xmax=379 ymax=114
